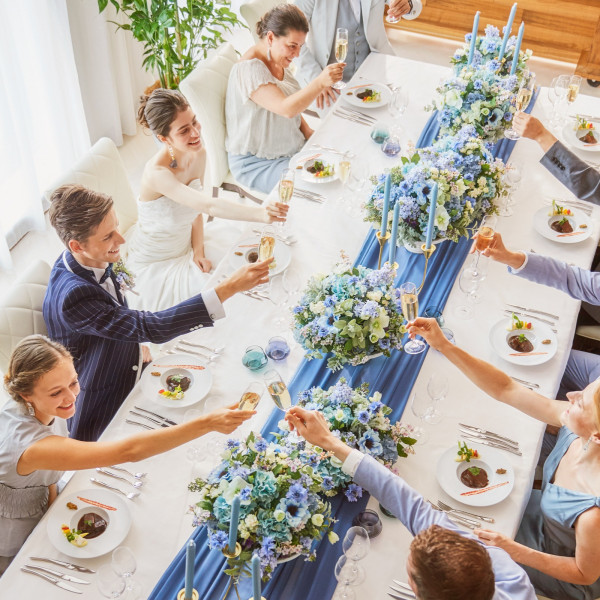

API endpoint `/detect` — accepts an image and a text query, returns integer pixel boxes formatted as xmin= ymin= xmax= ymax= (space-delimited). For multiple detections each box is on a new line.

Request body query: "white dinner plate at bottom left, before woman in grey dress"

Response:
xmin=47 ymin=489 xmax=131 ymax=558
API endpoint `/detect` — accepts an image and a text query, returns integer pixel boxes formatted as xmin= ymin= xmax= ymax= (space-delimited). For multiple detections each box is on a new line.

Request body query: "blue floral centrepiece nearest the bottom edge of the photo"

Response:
xmin=189 ymin=433 xmax=338 ymax=579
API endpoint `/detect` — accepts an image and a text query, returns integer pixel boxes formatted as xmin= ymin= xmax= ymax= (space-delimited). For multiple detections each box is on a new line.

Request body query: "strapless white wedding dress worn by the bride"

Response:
xmin=125 ymin=179 xmax=239 ymax=311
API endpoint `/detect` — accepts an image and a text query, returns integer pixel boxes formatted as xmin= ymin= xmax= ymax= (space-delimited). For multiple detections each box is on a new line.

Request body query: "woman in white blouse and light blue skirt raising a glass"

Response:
xmin=225 ymin=4 xmax=344 ymax=193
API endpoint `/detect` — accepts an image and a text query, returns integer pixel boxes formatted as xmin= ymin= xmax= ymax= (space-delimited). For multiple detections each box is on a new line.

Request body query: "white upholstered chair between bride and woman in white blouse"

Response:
xmin=179 ymin=43 xmax=265 ymax=202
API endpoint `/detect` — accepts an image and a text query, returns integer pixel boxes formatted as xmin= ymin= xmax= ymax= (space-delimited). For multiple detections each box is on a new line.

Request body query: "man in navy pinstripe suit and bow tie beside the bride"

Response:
xmin=43 ymin=185 xmax=270 ymax=441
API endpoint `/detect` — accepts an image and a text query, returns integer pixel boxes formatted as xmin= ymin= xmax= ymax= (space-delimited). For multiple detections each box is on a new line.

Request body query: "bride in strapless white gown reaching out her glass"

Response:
xmin=126 ymin=89 xmax=288 ymax=311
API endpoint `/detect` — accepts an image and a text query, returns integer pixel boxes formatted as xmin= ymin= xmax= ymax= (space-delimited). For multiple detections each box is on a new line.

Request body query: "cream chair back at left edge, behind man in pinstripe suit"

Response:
xmin=0 ymin=260 xmax=51 ymax=373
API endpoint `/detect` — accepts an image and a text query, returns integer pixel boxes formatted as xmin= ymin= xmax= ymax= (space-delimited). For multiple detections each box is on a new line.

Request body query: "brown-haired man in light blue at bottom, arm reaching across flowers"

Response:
xmin=286 ymin=406 xmax=536 ymax=600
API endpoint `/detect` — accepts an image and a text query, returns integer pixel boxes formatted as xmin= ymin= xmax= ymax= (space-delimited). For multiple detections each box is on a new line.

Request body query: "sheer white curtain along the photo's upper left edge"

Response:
xmin=0 ymin=0 xmax=90 ymax=268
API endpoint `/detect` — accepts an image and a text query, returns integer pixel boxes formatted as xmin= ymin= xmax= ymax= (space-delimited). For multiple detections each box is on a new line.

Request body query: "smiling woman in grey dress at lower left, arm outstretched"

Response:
xmin=0 ymin=335 xmax=255 ymax=575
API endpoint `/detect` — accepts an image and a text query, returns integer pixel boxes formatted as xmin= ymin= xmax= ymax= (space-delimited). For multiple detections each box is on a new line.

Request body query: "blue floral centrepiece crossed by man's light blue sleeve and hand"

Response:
xmin=278 ymin=377 xmax=416 ymax=502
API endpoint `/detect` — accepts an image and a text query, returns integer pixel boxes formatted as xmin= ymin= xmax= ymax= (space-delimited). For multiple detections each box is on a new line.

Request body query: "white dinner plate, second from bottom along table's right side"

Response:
xmin=490 ymin=317 xmax=558 ymax=366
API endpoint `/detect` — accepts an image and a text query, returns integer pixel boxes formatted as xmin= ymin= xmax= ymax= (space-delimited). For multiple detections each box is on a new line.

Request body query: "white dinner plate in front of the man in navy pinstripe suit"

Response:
xmin=141 ymin=354 xmax=212 ymax=408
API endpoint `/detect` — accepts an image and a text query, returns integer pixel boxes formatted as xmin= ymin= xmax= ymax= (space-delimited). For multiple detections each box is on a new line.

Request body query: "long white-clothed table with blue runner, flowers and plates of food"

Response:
xmin=0 ymin=5 xmax=600 ymax=600
